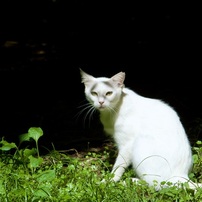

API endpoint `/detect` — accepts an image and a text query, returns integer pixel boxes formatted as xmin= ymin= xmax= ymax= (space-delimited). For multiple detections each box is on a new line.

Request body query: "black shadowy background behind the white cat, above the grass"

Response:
xmin=0 ymin=0 xmax=202 ymax=152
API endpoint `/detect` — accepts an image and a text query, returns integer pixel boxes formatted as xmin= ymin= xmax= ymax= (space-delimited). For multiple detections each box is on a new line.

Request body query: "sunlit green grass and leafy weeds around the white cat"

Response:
xmin=0 ymin=127 xmax=202 ymax=202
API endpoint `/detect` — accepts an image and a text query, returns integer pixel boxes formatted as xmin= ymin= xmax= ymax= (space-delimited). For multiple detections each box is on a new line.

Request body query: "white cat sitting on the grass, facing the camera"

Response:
xmin=80 ymin=69 xmax=201 ymax=189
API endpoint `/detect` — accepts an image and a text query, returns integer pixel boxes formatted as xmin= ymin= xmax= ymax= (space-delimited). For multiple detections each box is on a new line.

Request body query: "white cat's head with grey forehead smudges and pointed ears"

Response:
xmin=80 ymin=69 xmax=125 ymax=111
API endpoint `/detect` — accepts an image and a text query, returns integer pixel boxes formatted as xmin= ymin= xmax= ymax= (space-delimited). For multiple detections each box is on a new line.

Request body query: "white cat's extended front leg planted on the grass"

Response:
xmin=109 ymin=148 xmax=131 ymax=182
